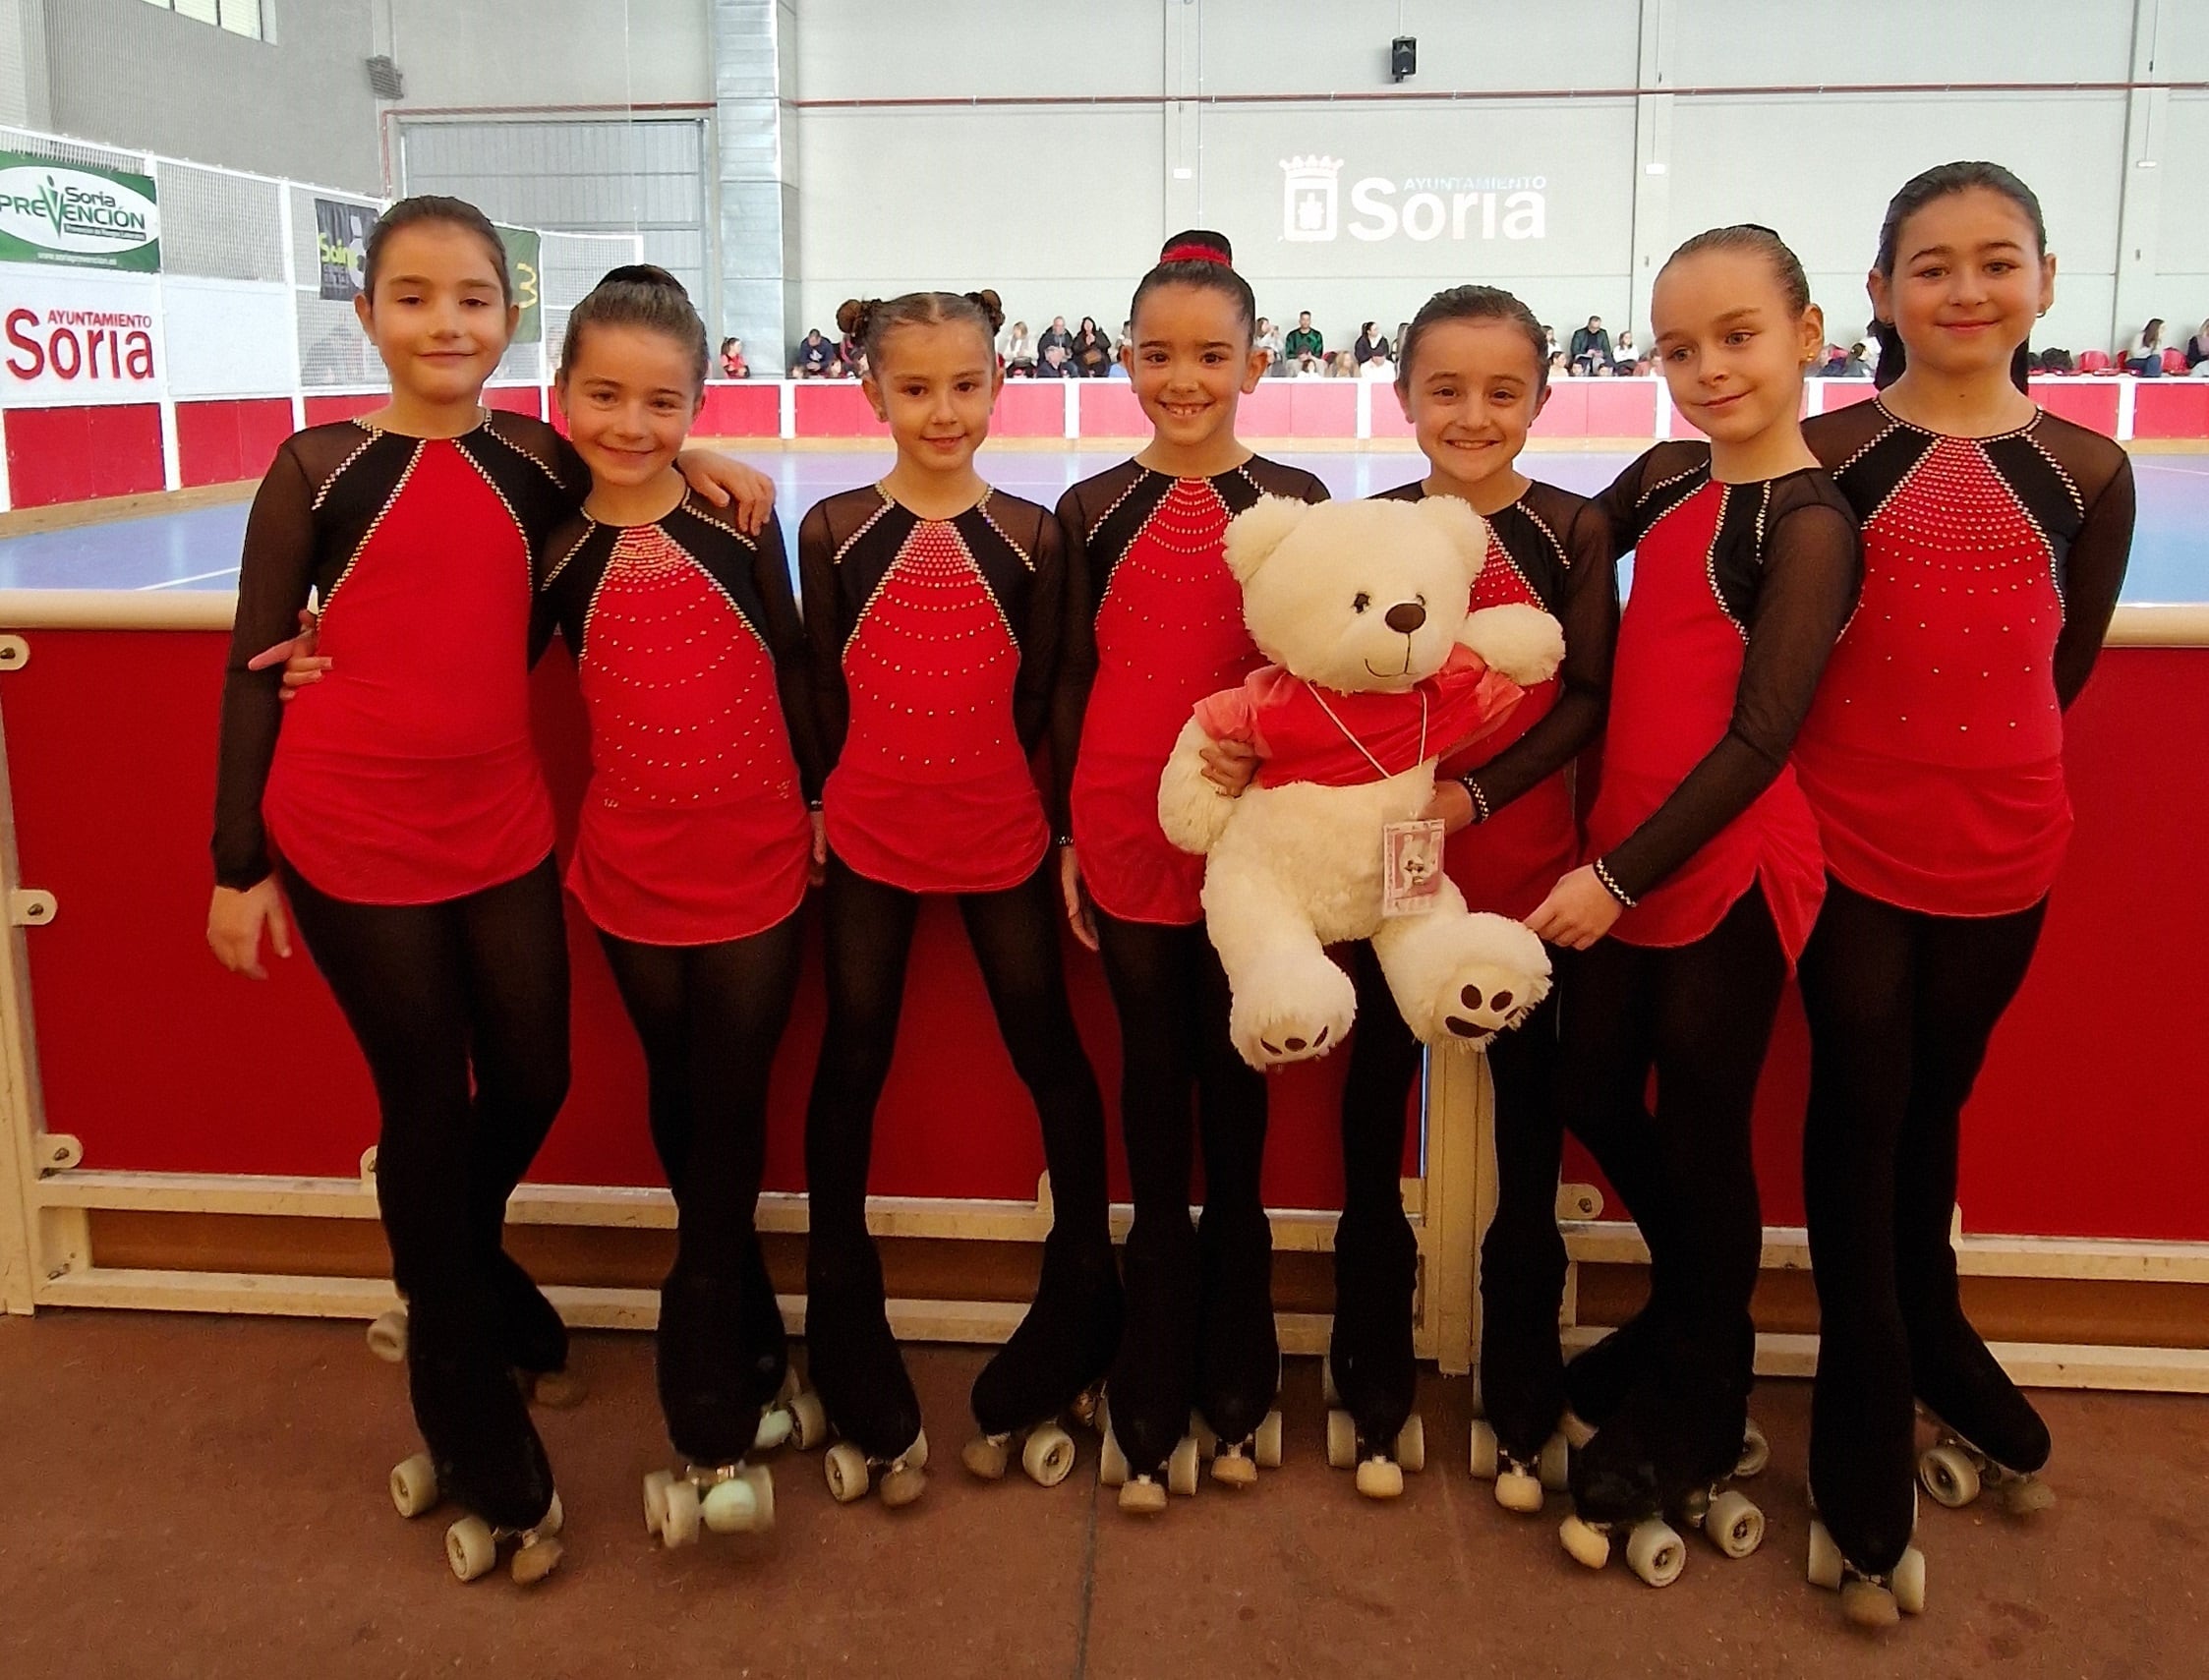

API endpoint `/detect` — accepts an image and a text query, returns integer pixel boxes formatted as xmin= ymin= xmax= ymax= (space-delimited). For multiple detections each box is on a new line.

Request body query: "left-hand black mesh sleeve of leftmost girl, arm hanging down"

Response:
xmin=214 ymin=441 xmax=316 ymax=890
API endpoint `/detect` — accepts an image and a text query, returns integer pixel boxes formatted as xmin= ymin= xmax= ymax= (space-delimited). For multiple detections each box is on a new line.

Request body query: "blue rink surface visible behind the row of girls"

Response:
xmin=0 ymin=448 xmax=2209 ymax=605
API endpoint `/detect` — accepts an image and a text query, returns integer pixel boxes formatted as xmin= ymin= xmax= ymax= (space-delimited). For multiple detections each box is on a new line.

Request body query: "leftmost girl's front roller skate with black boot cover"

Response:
xmin=388 ymin=1309 xmax=563 ymax=1588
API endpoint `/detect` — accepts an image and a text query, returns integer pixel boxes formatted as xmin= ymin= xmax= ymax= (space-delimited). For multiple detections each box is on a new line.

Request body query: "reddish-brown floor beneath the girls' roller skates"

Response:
xmin=0 ymin=1311 xmax=2209 ymax=1680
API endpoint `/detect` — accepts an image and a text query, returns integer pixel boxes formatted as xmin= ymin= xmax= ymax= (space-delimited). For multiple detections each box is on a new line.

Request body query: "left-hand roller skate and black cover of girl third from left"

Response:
xmin=806 ymin=1232 xmax=928 ymax=1508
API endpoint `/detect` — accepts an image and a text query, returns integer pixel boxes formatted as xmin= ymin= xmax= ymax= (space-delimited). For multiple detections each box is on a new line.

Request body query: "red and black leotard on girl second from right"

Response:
xmin=1589 ymin=441 xmax=1862 ymax=962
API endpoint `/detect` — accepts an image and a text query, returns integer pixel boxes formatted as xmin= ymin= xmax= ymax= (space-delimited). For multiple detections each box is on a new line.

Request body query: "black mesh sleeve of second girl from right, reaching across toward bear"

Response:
xmin=1601 ymin=501 xmax=1864 ymax=900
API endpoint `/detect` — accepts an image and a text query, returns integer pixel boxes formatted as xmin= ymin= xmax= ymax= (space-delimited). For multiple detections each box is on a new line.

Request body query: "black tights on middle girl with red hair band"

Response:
xmin=1096 ymin=911 xmax=1279 ymax=1475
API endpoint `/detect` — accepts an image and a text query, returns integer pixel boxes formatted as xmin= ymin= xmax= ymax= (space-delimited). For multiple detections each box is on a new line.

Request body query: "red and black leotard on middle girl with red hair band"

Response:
xmin=1054 ymin=455 xmax=1327 ymax=927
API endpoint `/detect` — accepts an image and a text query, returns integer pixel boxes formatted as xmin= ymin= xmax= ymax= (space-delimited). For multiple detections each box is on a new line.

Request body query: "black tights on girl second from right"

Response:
xmin=1557 ymin=888 xmax=1787 ymax=1517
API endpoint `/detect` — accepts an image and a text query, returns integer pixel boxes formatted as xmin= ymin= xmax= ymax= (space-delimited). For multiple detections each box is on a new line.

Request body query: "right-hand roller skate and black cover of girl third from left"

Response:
xmin=960 ymin=1232 xmax=1122 ymax=1488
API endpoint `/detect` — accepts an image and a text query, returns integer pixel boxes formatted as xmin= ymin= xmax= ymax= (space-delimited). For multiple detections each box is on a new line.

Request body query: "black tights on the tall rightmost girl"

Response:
xmin=1803 ymin=881 xmax=2048 ymax=1574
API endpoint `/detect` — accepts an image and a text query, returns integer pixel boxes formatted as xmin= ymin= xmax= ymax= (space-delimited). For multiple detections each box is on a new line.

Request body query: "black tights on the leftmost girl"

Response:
xmin=285 ymin=856 xmax=567 ymax=1528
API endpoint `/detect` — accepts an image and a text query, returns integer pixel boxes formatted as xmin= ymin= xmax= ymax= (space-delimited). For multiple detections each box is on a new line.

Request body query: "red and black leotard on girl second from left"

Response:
xmin=537 ymin=496 xmax=820 ymax=945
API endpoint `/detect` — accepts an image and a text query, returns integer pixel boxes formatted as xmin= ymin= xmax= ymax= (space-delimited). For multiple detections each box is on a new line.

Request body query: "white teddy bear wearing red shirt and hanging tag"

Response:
xmin=1157 ymin=496 xmax=1564 ymax=1069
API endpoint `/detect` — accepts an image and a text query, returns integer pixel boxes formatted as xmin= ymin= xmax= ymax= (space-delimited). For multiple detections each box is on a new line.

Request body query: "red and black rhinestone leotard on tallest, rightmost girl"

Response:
xmin=1796 ymin=402 xmax=2134 ymax=916
